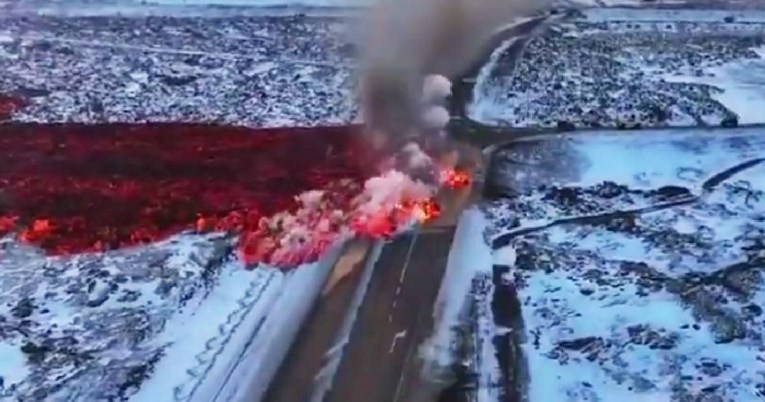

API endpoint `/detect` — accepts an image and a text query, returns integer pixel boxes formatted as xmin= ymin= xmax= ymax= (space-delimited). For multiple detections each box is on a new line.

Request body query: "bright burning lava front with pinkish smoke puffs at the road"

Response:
xmin=233 ymin=163 xmax=460 ymax=267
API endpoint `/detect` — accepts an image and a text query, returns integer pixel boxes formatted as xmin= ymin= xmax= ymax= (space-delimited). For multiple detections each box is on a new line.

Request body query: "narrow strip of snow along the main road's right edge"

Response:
xmin=423 ymin=207 xmax=492 ymax=370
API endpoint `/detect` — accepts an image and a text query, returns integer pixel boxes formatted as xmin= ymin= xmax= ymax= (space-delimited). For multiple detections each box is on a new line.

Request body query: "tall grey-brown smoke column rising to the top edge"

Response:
xmin=359 ymin=0 xmax=549 ymax=146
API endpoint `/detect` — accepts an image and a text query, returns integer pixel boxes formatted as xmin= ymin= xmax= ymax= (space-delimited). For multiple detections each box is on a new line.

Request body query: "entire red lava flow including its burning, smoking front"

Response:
xmin=0 ymin=124 xmax=464 ymax=267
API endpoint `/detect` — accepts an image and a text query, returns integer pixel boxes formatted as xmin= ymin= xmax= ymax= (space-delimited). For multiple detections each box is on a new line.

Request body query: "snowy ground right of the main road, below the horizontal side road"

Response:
xmin=487 ymin=129 xmax=765 ymax=402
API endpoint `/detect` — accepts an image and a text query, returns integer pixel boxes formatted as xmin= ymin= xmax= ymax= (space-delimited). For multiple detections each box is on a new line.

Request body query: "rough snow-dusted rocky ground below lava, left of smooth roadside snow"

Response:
xmin=0 ymin=232 xmax=239 ymax=400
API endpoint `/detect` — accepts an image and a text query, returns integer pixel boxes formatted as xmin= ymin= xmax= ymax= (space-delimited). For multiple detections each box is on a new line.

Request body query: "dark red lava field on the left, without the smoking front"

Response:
xmin=0 ymin=124 xmax=368 ymax=254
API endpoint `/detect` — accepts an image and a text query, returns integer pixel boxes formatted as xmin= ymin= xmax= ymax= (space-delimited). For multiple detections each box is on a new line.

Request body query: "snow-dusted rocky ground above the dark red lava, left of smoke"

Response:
xmin=0 ymin=15 xmax=355 ymax=126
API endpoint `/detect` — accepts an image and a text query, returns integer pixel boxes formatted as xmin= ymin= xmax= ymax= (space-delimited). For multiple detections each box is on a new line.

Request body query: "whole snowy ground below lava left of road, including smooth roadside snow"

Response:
xmin=0 ymin=235 xmax=339 ymax=401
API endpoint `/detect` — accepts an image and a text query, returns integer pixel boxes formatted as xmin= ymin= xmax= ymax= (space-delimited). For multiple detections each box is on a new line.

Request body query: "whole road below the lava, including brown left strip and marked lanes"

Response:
xmin=264 ymin=185 xmax=477 ymax=402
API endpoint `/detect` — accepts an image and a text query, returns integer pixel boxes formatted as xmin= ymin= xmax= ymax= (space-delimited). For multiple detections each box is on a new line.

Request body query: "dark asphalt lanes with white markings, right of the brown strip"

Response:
xmin=323 ymin=227 xmax=454 ymax=402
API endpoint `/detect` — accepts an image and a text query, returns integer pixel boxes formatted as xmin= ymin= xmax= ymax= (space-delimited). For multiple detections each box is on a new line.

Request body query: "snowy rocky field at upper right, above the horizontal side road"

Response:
xmin=468 ymin=8 xmax=765 ymax=127
